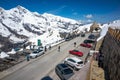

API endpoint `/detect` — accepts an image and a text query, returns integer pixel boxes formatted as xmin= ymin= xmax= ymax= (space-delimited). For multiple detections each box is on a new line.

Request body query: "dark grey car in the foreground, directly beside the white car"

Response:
xmin=55 ymin=63 xmax=74 ymax=80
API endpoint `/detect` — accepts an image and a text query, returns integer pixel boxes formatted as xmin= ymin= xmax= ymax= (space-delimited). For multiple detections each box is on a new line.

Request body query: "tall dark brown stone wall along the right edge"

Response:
xmin=100 ymin=28 xmax=120 ymax=80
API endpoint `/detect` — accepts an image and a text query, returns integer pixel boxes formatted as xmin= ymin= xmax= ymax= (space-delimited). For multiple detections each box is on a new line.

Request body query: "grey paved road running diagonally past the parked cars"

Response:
xmin=2 ymin=34 xmax=89 ymax=80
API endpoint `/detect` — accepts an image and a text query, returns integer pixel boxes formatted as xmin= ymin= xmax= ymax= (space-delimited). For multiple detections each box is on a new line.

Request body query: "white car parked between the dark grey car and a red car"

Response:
xmin=64 ymin=57 xmax=84 ymax=70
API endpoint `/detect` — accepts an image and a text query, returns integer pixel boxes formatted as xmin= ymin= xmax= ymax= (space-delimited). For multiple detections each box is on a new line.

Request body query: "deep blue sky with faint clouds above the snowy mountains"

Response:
xmin=0 ymin=0 xmax=120 ymax=23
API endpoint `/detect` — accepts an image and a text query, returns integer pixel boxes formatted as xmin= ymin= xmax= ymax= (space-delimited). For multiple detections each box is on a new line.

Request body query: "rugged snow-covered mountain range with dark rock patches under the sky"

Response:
xmin=0 ymin=6 xmax=81 ymax=51
